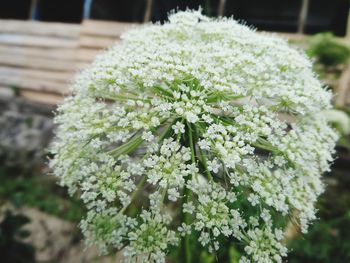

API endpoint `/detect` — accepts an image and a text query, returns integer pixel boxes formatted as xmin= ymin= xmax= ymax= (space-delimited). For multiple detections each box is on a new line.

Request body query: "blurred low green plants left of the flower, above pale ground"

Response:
xmin=0 ymin=167 xmax=83 ymax=222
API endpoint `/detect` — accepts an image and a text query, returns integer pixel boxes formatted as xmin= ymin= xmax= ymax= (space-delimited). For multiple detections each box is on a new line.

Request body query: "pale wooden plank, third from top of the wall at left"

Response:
xmin=0 ymin=45 xmax=100 ymax=62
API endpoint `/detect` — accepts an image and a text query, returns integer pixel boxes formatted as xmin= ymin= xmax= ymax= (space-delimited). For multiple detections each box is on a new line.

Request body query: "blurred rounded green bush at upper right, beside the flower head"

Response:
xmin=307 ymin=33 xmax=350 ymax=66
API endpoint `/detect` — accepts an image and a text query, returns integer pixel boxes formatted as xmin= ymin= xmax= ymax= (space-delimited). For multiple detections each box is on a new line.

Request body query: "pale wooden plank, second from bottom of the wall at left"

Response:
xmin=0 ymin=76 xmax=69 ymax=94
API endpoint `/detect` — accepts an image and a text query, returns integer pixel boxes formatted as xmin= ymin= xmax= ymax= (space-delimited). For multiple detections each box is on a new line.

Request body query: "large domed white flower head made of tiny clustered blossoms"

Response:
xmin=50 ymin=11 xmax=337 ymax=262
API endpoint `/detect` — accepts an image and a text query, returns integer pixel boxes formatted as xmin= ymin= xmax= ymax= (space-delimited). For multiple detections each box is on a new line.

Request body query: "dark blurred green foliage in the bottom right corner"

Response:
xmin=288 ymin=171 xmax=350 ymax=263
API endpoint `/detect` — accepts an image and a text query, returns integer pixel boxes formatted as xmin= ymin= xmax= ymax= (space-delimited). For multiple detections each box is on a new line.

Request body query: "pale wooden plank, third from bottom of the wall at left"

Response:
xmin=0 ymin=66 xmax=74 ymax=83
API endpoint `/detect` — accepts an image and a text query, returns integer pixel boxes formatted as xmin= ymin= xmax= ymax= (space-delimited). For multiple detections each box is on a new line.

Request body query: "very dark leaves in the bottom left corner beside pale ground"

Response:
xmin=0 ymin=211 xmax=36 ymax=263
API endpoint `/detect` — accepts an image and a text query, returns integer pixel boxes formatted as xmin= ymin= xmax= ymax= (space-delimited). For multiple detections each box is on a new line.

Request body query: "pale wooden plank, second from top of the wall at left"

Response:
xmin=0 ymin=33 xmax=78 ymax=48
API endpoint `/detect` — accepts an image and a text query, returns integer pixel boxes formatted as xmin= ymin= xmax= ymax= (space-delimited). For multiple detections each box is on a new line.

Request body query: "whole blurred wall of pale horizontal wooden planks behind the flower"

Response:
xmin=0 ymin=20 xmax=350 ymax=106
